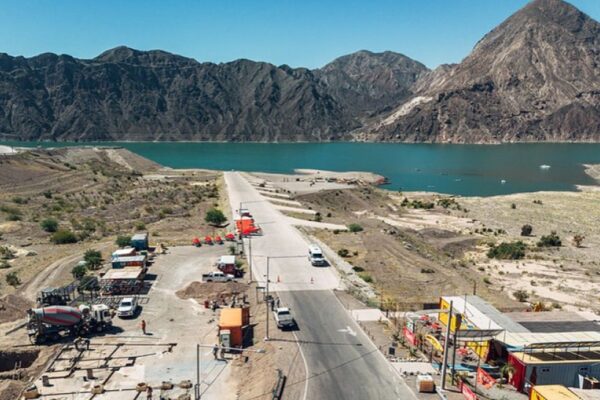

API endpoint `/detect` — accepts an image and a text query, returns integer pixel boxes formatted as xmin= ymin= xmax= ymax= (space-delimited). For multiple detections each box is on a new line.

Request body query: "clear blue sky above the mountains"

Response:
xmin=0 ymin=0 xmax=600 ymax=68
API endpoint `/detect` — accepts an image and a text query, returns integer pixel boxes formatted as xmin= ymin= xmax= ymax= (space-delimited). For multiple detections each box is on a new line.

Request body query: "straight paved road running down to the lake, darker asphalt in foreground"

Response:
xmin=225 ymin=172 xmax=415 ymax=400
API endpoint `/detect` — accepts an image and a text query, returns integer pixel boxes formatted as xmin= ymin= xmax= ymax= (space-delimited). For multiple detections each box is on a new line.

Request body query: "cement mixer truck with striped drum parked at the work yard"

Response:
xmin=27 ymin=304 xmax=112 ymax=344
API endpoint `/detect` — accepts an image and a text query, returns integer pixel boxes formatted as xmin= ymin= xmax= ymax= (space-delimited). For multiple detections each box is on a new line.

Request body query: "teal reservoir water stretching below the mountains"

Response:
xmin=0 ymin=142 xmax=600 ymax=196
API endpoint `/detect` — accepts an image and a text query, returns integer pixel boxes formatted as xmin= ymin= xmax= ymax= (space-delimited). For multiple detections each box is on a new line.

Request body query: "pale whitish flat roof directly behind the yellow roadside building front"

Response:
xmin=442 ymin=296 xmax=529 ymax=332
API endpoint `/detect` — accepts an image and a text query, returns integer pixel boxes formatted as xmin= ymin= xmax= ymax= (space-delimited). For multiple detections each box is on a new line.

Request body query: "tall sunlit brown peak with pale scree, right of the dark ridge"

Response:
xmin=364 ymin=0 xmax=600 ymax=143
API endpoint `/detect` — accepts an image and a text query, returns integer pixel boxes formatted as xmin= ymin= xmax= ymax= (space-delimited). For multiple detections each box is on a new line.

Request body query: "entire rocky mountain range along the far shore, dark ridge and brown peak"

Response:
xmin=0 ymin=0 xmax=600 ymax=143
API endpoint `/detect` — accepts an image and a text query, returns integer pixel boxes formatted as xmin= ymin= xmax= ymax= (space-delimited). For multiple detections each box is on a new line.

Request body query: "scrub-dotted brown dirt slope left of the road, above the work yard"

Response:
xmin=0 ymin=147 xmax=226 ymax=299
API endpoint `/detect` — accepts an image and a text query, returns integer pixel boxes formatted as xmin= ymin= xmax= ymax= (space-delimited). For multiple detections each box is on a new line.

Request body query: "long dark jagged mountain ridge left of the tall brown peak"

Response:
xmin=0 ymin=47 xmax=427 ymax=141
